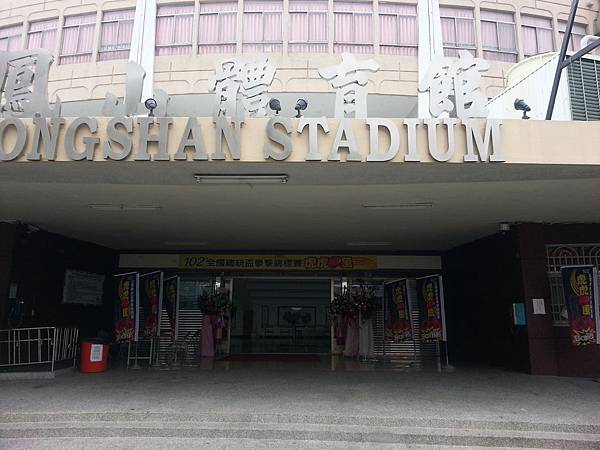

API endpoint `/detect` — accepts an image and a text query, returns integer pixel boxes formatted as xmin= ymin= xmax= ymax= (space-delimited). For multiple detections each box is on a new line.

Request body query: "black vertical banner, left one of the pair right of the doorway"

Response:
xmin=385 ymin=280 xmax=412 ymax=342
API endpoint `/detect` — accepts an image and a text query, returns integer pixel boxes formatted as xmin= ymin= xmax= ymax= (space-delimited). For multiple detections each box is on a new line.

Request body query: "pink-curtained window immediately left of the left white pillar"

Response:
xmin=98 ymin=9 xmax=135 ymax=61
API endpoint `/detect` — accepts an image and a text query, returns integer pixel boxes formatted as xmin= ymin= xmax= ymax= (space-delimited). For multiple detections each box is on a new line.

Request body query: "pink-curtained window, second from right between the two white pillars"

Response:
xmin=333 ymin=1 xmax=373 ymax=53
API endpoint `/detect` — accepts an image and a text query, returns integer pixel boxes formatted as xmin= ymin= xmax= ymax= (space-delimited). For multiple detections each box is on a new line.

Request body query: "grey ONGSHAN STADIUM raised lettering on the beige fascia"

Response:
xmin=0 ymin=116 xmax=505 ymax=162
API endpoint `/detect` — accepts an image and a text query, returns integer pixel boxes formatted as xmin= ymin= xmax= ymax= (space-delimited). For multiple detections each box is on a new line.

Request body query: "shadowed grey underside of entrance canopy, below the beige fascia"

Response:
xmin=0 ymin=162 xmax=600 ymax=252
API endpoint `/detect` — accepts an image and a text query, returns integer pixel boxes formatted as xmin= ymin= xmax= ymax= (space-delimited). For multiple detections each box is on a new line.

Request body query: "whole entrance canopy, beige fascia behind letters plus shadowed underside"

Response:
xmin=0 ymin=118 xmax=600 ymax=254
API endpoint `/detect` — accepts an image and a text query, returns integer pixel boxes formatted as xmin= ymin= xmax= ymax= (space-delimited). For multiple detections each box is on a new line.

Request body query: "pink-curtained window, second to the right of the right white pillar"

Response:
xmin=481 ymin=10 xmax=517 ymax=62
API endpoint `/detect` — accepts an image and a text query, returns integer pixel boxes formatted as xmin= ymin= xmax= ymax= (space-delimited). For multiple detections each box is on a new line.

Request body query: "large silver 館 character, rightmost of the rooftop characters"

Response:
xmin=419 ymin=50 xmax=489 ymax=119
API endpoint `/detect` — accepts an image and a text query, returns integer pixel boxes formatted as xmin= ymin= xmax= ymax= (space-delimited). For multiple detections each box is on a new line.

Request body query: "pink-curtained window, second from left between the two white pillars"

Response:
xmin=198 ymin=2 xmax=237 ymax=54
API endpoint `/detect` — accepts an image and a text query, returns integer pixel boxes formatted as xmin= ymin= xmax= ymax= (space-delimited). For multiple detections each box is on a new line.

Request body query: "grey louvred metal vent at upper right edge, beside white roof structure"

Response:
xmin=568 ymin=58 xmax=600 ymax=120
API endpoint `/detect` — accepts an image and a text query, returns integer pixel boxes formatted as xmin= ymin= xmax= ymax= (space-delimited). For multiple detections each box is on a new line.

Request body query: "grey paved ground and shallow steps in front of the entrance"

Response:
xmin=0 ymin=363 xmax=600 ymax=448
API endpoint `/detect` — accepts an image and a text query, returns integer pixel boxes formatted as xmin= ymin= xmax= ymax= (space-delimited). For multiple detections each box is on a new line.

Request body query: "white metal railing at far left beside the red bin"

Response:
xmin=0 ymin=327 xmax=79 ymax=372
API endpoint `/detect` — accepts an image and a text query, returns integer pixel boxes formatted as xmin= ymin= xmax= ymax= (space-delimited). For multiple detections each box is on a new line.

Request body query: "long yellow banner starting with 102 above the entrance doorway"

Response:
xmin=178 ymin=253 xmax=377 ymax=271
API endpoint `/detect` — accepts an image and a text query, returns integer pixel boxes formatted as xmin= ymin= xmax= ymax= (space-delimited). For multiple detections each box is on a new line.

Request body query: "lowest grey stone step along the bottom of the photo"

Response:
xmin=0 ymin=415 xmax=600 ymax=449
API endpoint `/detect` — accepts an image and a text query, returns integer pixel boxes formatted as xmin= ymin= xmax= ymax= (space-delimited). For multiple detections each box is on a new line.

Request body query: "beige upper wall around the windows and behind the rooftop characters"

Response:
xmin=0 ymin=0 xmax=598 ymax=102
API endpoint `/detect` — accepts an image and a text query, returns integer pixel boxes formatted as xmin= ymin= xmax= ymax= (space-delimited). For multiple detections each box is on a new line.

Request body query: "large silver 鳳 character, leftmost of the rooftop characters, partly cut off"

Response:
xmin=0 ymin=49 xmax=60 ymax=117
